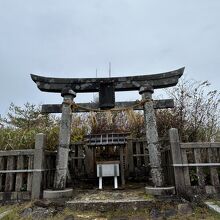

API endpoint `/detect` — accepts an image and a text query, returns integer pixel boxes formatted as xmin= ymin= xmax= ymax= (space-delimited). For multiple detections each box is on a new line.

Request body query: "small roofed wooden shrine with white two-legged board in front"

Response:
xmin=86 ymin=133 xmax=128 ymax=189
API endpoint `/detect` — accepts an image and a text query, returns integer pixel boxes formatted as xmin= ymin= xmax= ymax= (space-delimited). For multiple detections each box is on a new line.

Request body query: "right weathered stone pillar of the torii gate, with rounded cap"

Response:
xmin=139 ymin=85 xmax=164 ymax=187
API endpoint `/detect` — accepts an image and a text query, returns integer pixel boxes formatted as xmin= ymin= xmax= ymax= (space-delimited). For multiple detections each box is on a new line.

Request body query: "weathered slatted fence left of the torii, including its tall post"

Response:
xmin=0 ymin=134 xmax=56 ymax=201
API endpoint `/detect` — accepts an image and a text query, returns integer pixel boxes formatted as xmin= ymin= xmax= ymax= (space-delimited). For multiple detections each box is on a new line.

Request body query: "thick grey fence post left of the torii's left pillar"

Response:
xmin=31 ymin=133 xmax=46 ymax=199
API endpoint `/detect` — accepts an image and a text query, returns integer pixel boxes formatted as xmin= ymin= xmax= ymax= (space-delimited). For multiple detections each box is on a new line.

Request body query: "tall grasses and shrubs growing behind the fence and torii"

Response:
xmin=0 ymin=80 xmax=220 ymax=150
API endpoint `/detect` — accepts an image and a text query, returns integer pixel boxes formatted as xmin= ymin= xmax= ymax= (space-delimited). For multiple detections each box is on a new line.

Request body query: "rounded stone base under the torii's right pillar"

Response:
xmin=145 ymin=186 xmax=175 ymax=196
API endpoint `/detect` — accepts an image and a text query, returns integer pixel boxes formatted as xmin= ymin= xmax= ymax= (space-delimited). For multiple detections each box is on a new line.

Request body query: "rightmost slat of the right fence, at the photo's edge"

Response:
xmin=208 ymin=148 xmax=219 ymax=186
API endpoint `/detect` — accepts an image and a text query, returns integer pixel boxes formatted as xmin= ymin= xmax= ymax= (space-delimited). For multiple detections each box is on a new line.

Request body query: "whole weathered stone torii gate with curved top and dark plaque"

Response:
xmin=31 ymin=68 xmax=184 ymax=190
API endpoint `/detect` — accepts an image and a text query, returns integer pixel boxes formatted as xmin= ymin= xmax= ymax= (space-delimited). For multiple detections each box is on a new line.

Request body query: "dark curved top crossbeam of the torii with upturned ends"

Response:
xmin=31 ymin=67 xmax=184 ymax=93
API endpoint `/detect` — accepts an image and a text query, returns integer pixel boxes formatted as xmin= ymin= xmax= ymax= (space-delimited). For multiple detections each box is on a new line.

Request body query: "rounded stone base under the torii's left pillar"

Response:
xmin=43 ymin=189 xmax=73 ymax=199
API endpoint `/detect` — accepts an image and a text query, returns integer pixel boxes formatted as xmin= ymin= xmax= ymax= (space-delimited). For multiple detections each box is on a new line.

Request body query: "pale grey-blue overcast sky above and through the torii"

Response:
xmin=0 ymin=0 xmax=220 ymax=115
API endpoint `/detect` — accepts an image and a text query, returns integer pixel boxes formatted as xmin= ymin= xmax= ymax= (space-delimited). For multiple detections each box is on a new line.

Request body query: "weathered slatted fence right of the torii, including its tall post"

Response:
xmin=169 ymin=128 xmax=220 ymax=194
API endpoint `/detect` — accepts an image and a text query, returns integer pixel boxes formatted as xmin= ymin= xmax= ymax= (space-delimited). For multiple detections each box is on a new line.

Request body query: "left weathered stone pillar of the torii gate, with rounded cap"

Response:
xmin=54 ymin=88 xmax=76 ymax=190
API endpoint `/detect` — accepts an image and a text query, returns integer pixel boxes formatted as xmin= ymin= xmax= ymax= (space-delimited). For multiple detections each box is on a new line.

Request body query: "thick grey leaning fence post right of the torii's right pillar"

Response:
xmin=169 ymin=128 xmax=185 ymax=194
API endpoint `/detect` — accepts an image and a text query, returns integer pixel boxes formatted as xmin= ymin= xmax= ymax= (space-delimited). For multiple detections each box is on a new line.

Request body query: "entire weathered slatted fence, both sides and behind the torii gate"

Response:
xmin=0 ymin=129 xmax=220 ymax=201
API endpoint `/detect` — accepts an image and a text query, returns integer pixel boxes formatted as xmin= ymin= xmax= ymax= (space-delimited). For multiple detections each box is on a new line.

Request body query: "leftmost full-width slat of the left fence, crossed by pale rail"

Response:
xmin=5 ymin=156 xmax=15 ymax=192
